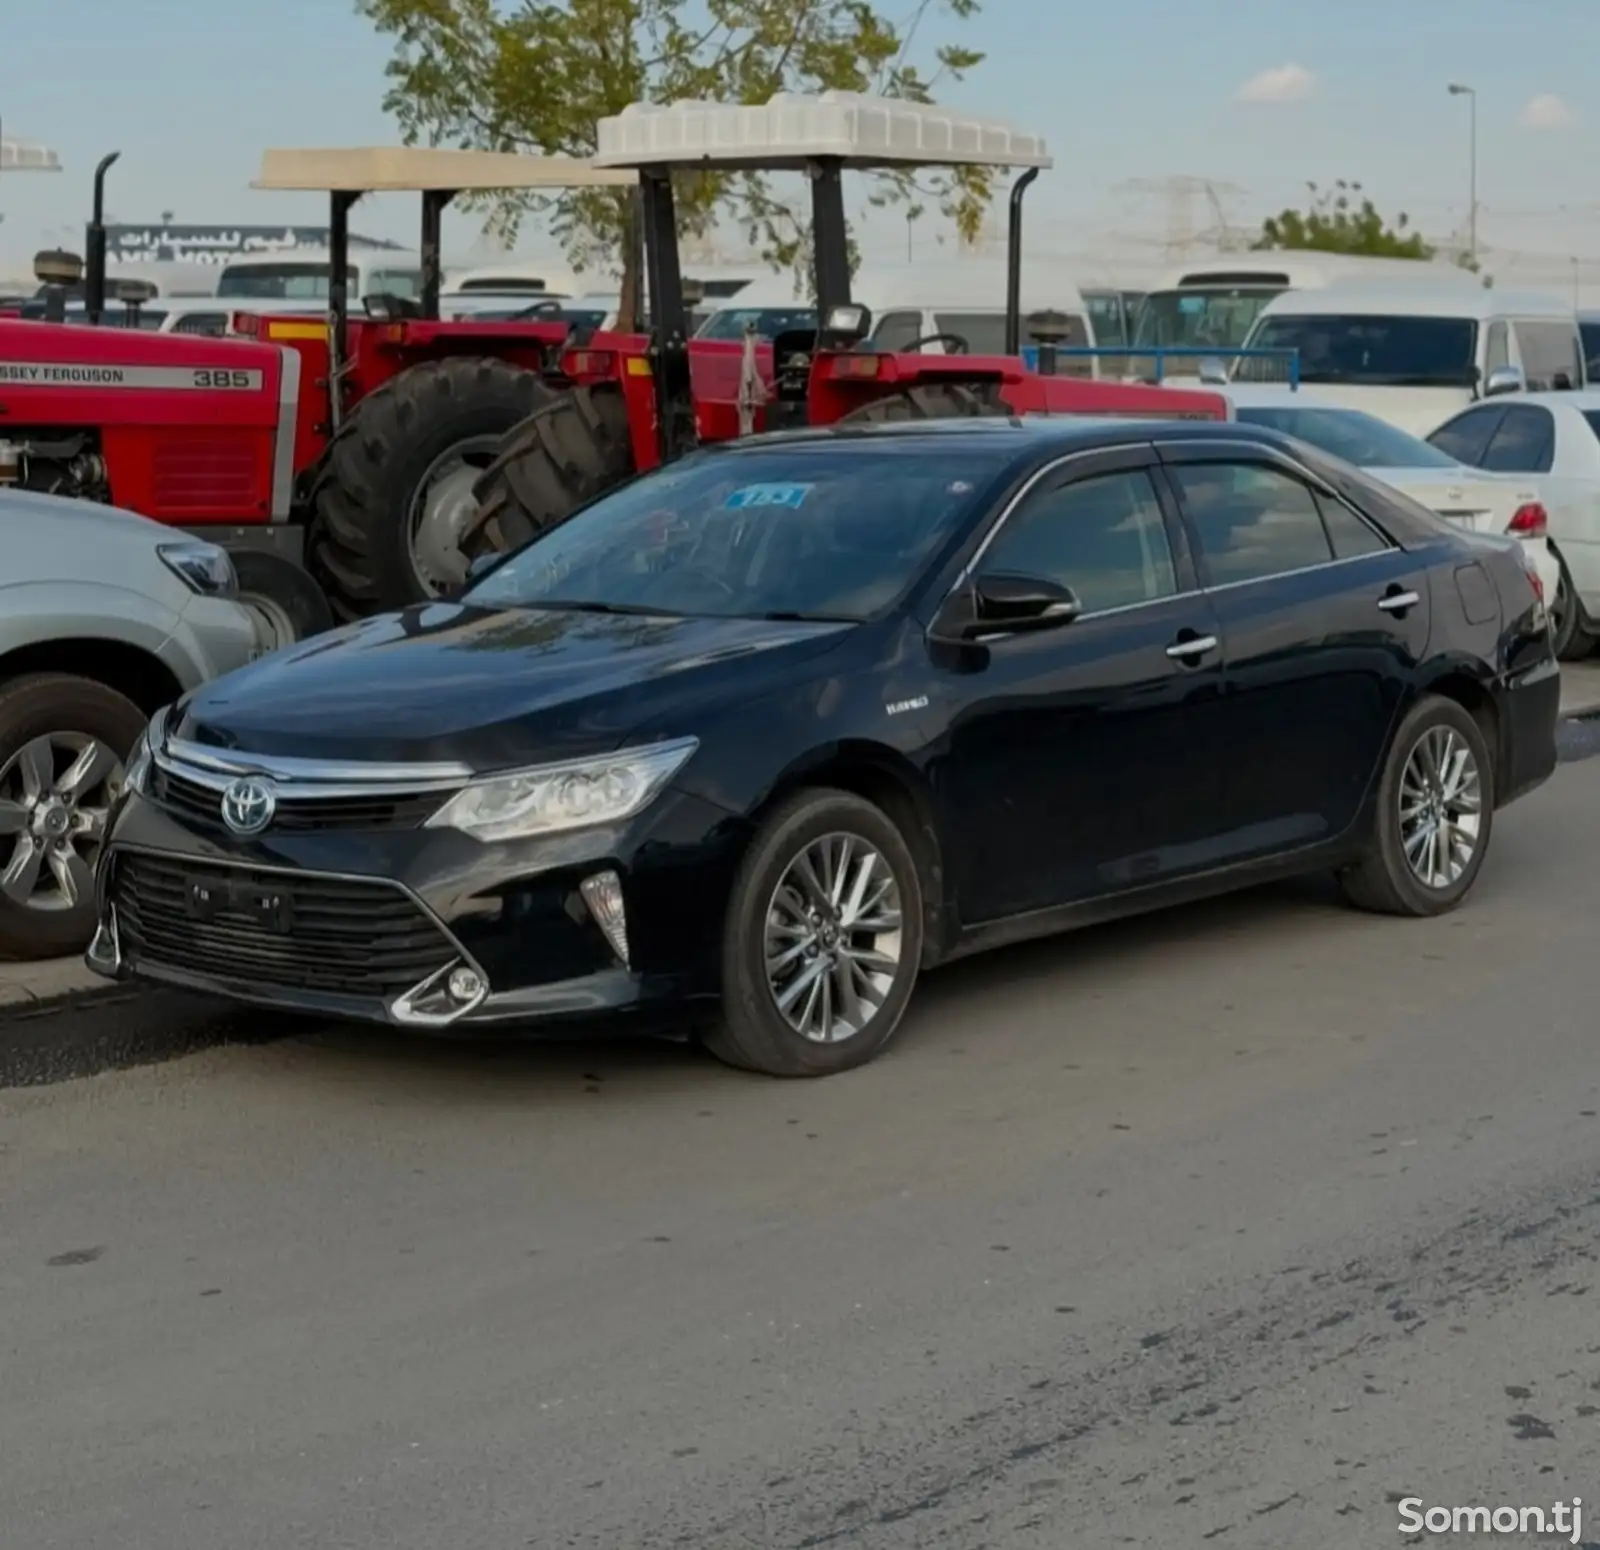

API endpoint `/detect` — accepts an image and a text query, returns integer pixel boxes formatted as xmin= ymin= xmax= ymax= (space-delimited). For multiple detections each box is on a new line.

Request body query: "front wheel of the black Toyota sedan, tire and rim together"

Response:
xmin=706 ymin=789 xmax=923 ymax=1077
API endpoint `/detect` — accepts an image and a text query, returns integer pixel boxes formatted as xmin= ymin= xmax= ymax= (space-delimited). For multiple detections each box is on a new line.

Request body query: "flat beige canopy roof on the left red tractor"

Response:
xmin=251 ymin=146 xmax=638 ymax=194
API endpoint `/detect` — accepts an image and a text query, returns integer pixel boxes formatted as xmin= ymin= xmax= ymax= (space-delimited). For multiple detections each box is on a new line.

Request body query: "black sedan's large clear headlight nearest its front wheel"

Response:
xmin=427 ymin=737 xmax=699 ymax=843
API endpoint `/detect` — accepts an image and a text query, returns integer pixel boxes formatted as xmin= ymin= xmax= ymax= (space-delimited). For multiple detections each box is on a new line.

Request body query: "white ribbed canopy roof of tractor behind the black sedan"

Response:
xmin=594 ymin=91 xmax=1053 ymax=171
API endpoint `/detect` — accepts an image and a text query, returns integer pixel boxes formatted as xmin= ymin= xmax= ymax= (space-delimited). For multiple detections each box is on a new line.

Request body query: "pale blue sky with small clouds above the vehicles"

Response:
xmin=0 ymin=0 xmax=1600 ymax=275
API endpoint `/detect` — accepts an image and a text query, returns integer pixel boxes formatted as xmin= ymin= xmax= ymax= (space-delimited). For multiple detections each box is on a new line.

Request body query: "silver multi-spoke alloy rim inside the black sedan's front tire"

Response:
xmin=765 ymin=833 xmax=902 ymax=1045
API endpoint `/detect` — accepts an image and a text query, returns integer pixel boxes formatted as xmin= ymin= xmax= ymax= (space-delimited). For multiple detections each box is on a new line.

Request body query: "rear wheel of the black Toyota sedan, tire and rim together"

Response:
xmin=1339 ymin=694 xmax=1494 ymax=917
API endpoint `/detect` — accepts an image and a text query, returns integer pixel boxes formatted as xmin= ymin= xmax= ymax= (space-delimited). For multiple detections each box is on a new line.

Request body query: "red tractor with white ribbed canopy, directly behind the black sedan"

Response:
xmin=469 ymin=93 xmax=1232 ymax=549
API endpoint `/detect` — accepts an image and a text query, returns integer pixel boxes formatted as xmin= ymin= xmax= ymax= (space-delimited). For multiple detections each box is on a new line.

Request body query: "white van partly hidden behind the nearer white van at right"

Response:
xmin=1133 ymin=262 xmax=1480 ymax=378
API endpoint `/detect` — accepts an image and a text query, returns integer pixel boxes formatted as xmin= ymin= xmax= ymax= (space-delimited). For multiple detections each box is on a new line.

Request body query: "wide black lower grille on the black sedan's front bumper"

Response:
xmin=109 ymin=851 xmax=461 ymax=1000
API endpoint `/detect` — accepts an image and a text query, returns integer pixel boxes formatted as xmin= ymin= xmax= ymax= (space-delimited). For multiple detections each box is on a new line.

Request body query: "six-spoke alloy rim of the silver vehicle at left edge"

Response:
xmin=0 ymin=731 xmax=123 ymax=910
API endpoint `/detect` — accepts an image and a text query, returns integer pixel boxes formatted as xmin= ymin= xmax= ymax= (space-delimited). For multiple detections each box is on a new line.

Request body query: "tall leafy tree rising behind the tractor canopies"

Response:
xmin=355 ymin=0 xmax=992 ymax=322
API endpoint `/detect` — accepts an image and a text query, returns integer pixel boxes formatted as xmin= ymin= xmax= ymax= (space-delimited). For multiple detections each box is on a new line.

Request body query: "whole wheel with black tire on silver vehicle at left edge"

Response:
xmin=0 ymin=673 xmax=149 ymax=960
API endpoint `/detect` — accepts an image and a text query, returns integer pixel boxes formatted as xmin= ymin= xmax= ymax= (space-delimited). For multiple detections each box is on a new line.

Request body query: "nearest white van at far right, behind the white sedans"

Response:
xmin=1232 ymin=280 xmax=1584 ymax=437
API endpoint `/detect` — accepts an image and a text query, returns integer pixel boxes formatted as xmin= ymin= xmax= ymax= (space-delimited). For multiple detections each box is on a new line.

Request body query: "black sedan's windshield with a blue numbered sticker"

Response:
xmin=466 ymin=437 xmax=1005 ymax=622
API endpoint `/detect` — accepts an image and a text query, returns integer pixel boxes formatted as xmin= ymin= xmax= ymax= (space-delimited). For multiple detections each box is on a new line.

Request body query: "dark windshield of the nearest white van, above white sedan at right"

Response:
xmin=1240 ymin=314 xmax=1478 ymax=387
